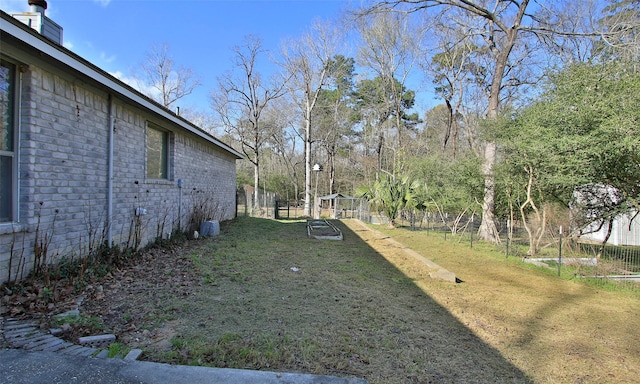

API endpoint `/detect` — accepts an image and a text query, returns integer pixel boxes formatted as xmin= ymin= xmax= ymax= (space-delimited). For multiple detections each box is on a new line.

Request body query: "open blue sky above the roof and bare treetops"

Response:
xmin=0 ymin=0 xmax=360 ymax=109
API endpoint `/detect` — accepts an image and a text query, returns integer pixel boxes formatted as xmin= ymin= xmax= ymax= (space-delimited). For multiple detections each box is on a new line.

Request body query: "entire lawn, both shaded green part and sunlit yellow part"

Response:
xmin=79 ymin=218 xmax=640 ymax=384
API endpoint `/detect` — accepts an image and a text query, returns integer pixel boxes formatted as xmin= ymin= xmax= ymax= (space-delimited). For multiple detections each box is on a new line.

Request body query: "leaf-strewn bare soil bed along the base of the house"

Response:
xmin=0 ymin=242 xmax=200 ymax=351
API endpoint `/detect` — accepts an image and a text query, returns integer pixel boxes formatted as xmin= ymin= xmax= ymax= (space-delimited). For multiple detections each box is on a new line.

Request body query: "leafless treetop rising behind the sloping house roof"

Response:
xmin=141 ymin=44 xmax=200 ymax=108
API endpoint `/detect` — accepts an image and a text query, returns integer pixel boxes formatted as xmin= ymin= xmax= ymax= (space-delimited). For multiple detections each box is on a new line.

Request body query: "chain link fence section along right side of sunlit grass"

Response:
xmin=357 ymin=204 xmax=640 ymax=291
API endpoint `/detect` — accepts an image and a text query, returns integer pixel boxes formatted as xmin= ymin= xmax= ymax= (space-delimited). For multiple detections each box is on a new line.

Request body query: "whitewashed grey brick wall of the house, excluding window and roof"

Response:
xmin=0 ymin=65 xmax=236 ymax=283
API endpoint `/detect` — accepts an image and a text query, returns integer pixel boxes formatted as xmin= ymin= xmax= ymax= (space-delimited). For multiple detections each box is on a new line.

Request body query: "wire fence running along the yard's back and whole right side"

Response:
xmin=237 ymin=187 xmax=640 ymax=290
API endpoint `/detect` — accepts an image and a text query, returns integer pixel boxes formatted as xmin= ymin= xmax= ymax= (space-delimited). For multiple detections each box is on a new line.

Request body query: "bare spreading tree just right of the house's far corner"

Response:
xmin=212 ymin=36 xmax=285 ymax=209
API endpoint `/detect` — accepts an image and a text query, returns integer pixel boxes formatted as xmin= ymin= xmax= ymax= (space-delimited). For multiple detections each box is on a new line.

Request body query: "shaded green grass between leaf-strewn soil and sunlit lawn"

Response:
xmin=171 ymin=218 xmax=532 ymax=383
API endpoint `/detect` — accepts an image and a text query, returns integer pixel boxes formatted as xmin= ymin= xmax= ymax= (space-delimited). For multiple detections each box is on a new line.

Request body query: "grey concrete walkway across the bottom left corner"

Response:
xmin=0 ymin=318 xmax=367 ymax=384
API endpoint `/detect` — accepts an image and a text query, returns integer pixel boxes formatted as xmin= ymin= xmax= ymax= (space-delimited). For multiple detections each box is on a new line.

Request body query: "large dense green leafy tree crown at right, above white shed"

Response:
xmin=499 ymin=63 xmax=640 ymax=224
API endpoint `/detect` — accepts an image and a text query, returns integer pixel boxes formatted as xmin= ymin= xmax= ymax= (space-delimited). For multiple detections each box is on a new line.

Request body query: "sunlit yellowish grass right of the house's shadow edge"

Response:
xmin=345 ymin=221 xmax=640 ymax=383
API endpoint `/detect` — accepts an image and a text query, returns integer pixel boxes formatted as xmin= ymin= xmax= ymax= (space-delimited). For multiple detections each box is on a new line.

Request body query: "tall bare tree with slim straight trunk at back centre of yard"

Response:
xmin=282 ymin=21 xmax=341 ymax=216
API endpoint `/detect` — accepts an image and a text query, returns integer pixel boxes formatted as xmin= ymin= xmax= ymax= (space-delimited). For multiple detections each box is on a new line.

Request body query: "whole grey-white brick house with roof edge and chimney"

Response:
xmin=0 ymin=0 xmax=242 ymax=283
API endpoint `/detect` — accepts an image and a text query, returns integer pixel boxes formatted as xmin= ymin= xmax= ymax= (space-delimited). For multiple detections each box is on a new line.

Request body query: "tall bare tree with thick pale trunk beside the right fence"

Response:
xmin=364 ymin=0 xmax=608 ymax=243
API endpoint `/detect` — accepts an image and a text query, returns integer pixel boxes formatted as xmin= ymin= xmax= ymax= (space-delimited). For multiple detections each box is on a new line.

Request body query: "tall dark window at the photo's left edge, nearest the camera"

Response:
xmin=0 ymin=59 xmax=17 ymax=222
